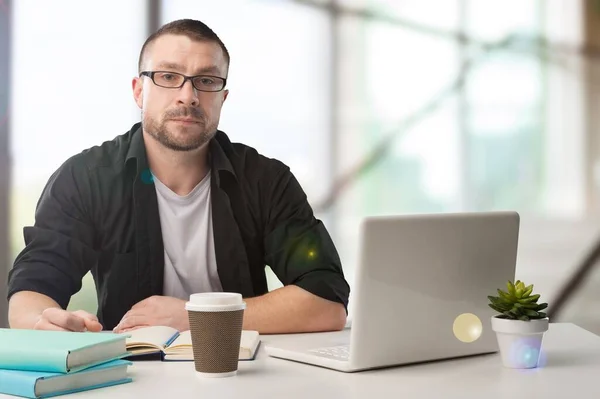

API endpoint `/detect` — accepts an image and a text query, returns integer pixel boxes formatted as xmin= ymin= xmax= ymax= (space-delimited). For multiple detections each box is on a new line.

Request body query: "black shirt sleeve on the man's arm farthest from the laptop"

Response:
xmin=8 ymin=159 xmax=97 ymax=309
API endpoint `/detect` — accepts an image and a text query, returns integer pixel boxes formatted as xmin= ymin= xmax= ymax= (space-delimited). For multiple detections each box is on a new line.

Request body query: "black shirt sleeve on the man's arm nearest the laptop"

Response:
xmin=265 ymin=164 xmax=350 ymax=312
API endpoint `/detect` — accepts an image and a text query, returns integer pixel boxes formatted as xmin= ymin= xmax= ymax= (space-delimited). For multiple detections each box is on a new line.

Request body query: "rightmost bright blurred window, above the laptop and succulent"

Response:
xmin=464 ymin=0 xmax=545 ymax=213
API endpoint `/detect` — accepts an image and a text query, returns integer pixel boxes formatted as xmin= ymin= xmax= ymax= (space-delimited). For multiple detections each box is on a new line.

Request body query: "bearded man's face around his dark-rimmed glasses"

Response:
xmin=133 ymin=34 xmax=228 ymax=151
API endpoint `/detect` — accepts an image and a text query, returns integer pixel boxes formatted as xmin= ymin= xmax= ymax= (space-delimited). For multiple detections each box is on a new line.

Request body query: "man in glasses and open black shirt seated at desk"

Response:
xmin=8 ymin=20 xmax=349 ymax=333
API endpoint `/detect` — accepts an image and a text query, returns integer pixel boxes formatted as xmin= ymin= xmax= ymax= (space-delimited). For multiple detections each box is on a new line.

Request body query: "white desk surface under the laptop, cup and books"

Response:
xmin=0 ymin=323 xmax=600 ymax=399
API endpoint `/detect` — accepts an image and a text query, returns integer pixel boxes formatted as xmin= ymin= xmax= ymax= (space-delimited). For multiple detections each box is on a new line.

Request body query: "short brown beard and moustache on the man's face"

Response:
xmin=142 ymin=107 xmax=217 ymax=152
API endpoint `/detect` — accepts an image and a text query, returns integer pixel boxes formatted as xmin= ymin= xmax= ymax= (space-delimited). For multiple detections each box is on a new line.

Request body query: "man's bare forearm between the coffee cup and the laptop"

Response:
xmin=244 ymin=285 xmax=346 ymax=334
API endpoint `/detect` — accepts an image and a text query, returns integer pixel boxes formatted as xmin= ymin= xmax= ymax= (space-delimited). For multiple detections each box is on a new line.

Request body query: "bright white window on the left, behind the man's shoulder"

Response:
xmin=11 ymin=0 xmax=146 ymax=309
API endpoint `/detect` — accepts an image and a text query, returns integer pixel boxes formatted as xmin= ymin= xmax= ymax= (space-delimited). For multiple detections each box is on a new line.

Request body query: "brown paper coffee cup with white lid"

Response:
xmin=185 ymin=292 xmax=246 ymax=377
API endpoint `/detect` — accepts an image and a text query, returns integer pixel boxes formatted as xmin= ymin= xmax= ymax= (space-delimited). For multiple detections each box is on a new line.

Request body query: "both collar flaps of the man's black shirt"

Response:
xmin=125 ymin=122 xmax=237 ymax=184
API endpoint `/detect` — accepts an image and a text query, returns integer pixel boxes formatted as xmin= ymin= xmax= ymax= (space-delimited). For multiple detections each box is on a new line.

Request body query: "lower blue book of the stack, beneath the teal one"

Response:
xmin=0 ymin=360 xmax=132 ymax=398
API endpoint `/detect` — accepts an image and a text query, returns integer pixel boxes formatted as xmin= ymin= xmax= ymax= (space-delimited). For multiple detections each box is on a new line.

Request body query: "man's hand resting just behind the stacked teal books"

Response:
xmin=33 ymin=308 xmax=102 ymax=332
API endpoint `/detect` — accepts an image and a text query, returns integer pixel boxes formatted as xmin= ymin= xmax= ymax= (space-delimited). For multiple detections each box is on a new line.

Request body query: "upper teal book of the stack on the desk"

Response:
xmin=0 ymin=329 xmax=129 ymax=373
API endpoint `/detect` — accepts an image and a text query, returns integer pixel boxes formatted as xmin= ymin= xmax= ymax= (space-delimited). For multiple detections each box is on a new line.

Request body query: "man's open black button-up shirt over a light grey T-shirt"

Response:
xmin=8 ymin=123 xmax=350 ymax=329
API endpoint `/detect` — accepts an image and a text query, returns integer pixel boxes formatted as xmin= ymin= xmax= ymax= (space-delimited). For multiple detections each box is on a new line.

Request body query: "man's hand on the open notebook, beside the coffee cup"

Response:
xmin=114 ymin=295 xmax=190 ymax=333
